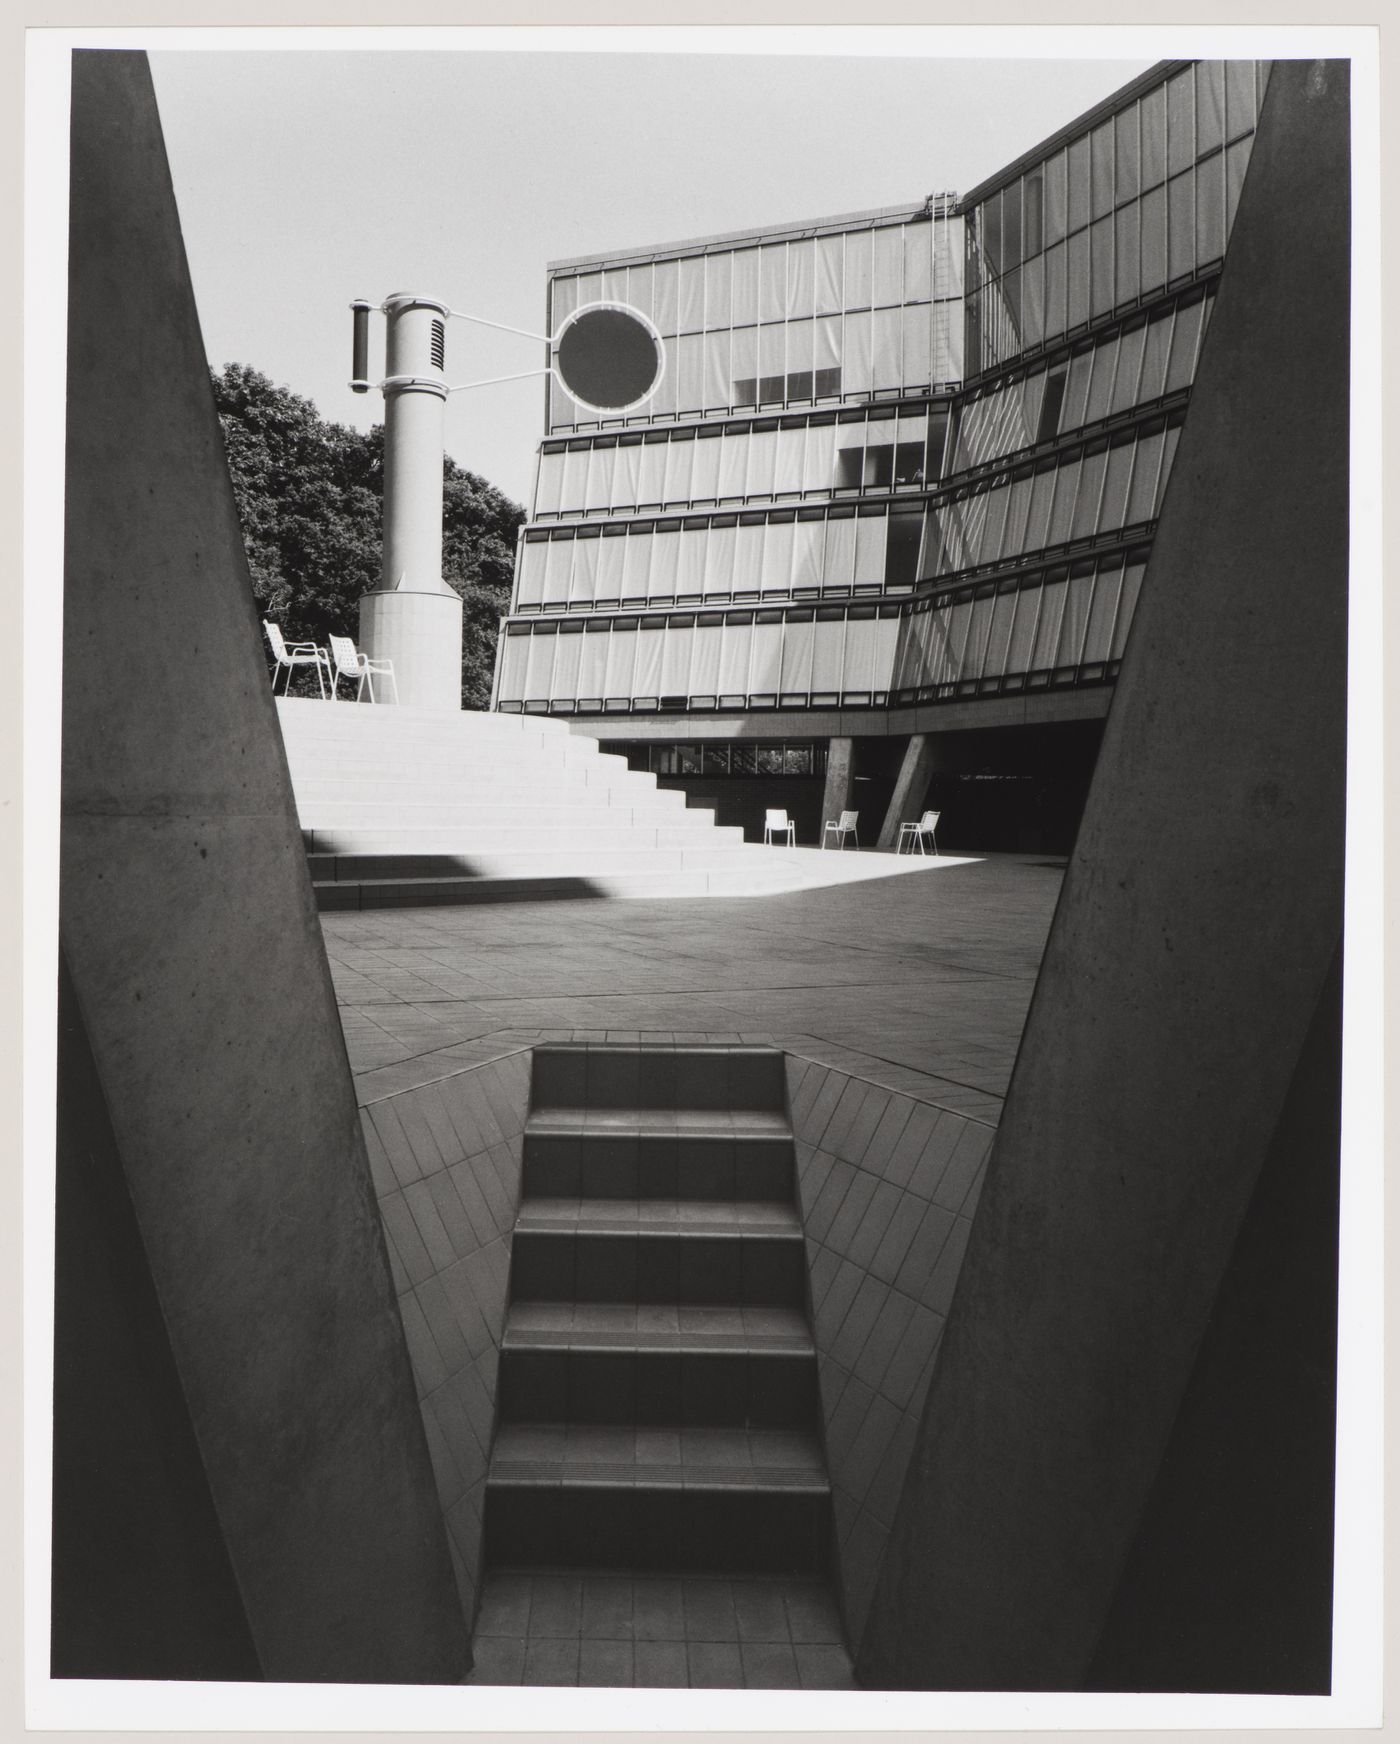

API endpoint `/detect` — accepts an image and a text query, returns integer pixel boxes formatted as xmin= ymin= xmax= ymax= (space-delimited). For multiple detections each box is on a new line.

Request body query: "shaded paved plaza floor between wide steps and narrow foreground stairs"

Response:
xmin=321 ymin=855 xmax=1064 ymax=1121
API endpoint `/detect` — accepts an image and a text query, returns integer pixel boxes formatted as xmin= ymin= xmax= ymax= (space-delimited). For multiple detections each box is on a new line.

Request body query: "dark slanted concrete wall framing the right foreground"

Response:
xmin=858 ymin=61 xmax=1349 ymax=1690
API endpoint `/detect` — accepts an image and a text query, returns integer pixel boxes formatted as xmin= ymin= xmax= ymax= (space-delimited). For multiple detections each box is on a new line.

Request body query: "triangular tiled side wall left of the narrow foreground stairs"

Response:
xmin=361 ymin=1048 xmax=530 ymax=1622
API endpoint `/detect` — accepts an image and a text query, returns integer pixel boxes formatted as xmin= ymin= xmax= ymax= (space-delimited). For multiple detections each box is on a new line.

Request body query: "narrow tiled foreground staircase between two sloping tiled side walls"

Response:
xmin=483 ymin=1045 xmax=849 ymax=1669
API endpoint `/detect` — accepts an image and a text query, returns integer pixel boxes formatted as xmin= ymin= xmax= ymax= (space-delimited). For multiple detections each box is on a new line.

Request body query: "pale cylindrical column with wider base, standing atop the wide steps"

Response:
xmin=359 ymin=291 xmax=462 ymax=710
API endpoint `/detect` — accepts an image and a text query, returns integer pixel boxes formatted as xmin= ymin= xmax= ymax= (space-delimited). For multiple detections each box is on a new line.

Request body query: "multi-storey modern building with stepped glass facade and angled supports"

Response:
xmin=495 ymin=61 xmax=1267 ymax=851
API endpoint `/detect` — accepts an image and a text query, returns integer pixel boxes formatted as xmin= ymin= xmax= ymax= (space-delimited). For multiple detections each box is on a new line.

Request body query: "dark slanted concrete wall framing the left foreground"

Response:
xmin=59 ymin=51 xmax=467 ymax=1681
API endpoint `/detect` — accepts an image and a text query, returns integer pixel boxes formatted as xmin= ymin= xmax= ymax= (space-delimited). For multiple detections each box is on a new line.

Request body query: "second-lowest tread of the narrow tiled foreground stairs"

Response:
xmin=500 ymin=1299 xmax=814 ymax=1355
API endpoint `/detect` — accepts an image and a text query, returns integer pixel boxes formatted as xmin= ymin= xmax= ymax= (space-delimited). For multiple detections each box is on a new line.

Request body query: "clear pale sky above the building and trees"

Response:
xmin=150 ymin=38 xmax=1151 ymax=502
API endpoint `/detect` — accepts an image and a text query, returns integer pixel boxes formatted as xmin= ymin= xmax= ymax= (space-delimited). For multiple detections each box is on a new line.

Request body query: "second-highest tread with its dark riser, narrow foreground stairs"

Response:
xmin=511 ymin=1200 xmax=805 ymax=1308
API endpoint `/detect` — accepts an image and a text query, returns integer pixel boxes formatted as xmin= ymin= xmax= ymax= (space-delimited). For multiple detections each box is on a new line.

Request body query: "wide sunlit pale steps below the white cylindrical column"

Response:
xmin=277 ymin=698 xmax=807 ymax=909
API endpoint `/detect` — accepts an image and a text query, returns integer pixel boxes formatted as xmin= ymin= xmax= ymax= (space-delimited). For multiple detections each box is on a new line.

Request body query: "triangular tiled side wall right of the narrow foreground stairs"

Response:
xmin=786 ymin=1055 xmax=996 ymax=1648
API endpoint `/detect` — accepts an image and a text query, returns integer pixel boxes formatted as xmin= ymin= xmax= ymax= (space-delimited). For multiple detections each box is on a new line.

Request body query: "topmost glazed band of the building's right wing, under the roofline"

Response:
xmin=966 ymin=61 xmax=1267 ymax=377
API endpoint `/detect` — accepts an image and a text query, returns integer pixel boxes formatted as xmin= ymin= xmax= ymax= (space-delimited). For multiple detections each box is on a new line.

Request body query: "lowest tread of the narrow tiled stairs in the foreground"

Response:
xmin=486 ymin=1423 xmax=830 ymax=1493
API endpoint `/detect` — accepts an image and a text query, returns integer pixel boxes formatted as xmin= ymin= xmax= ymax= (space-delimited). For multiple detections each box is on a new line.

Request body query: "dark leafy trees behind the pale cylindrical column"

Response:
xmin=213 ymin=363 xmax=525 ymax=708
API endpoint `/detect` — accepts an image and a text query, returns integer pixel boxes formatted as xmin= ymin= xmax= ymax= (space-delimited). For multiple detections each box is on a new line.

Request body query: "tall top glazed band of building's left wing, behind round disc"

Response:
xmin=549 ymin=202 xmax=964 ymax=431
